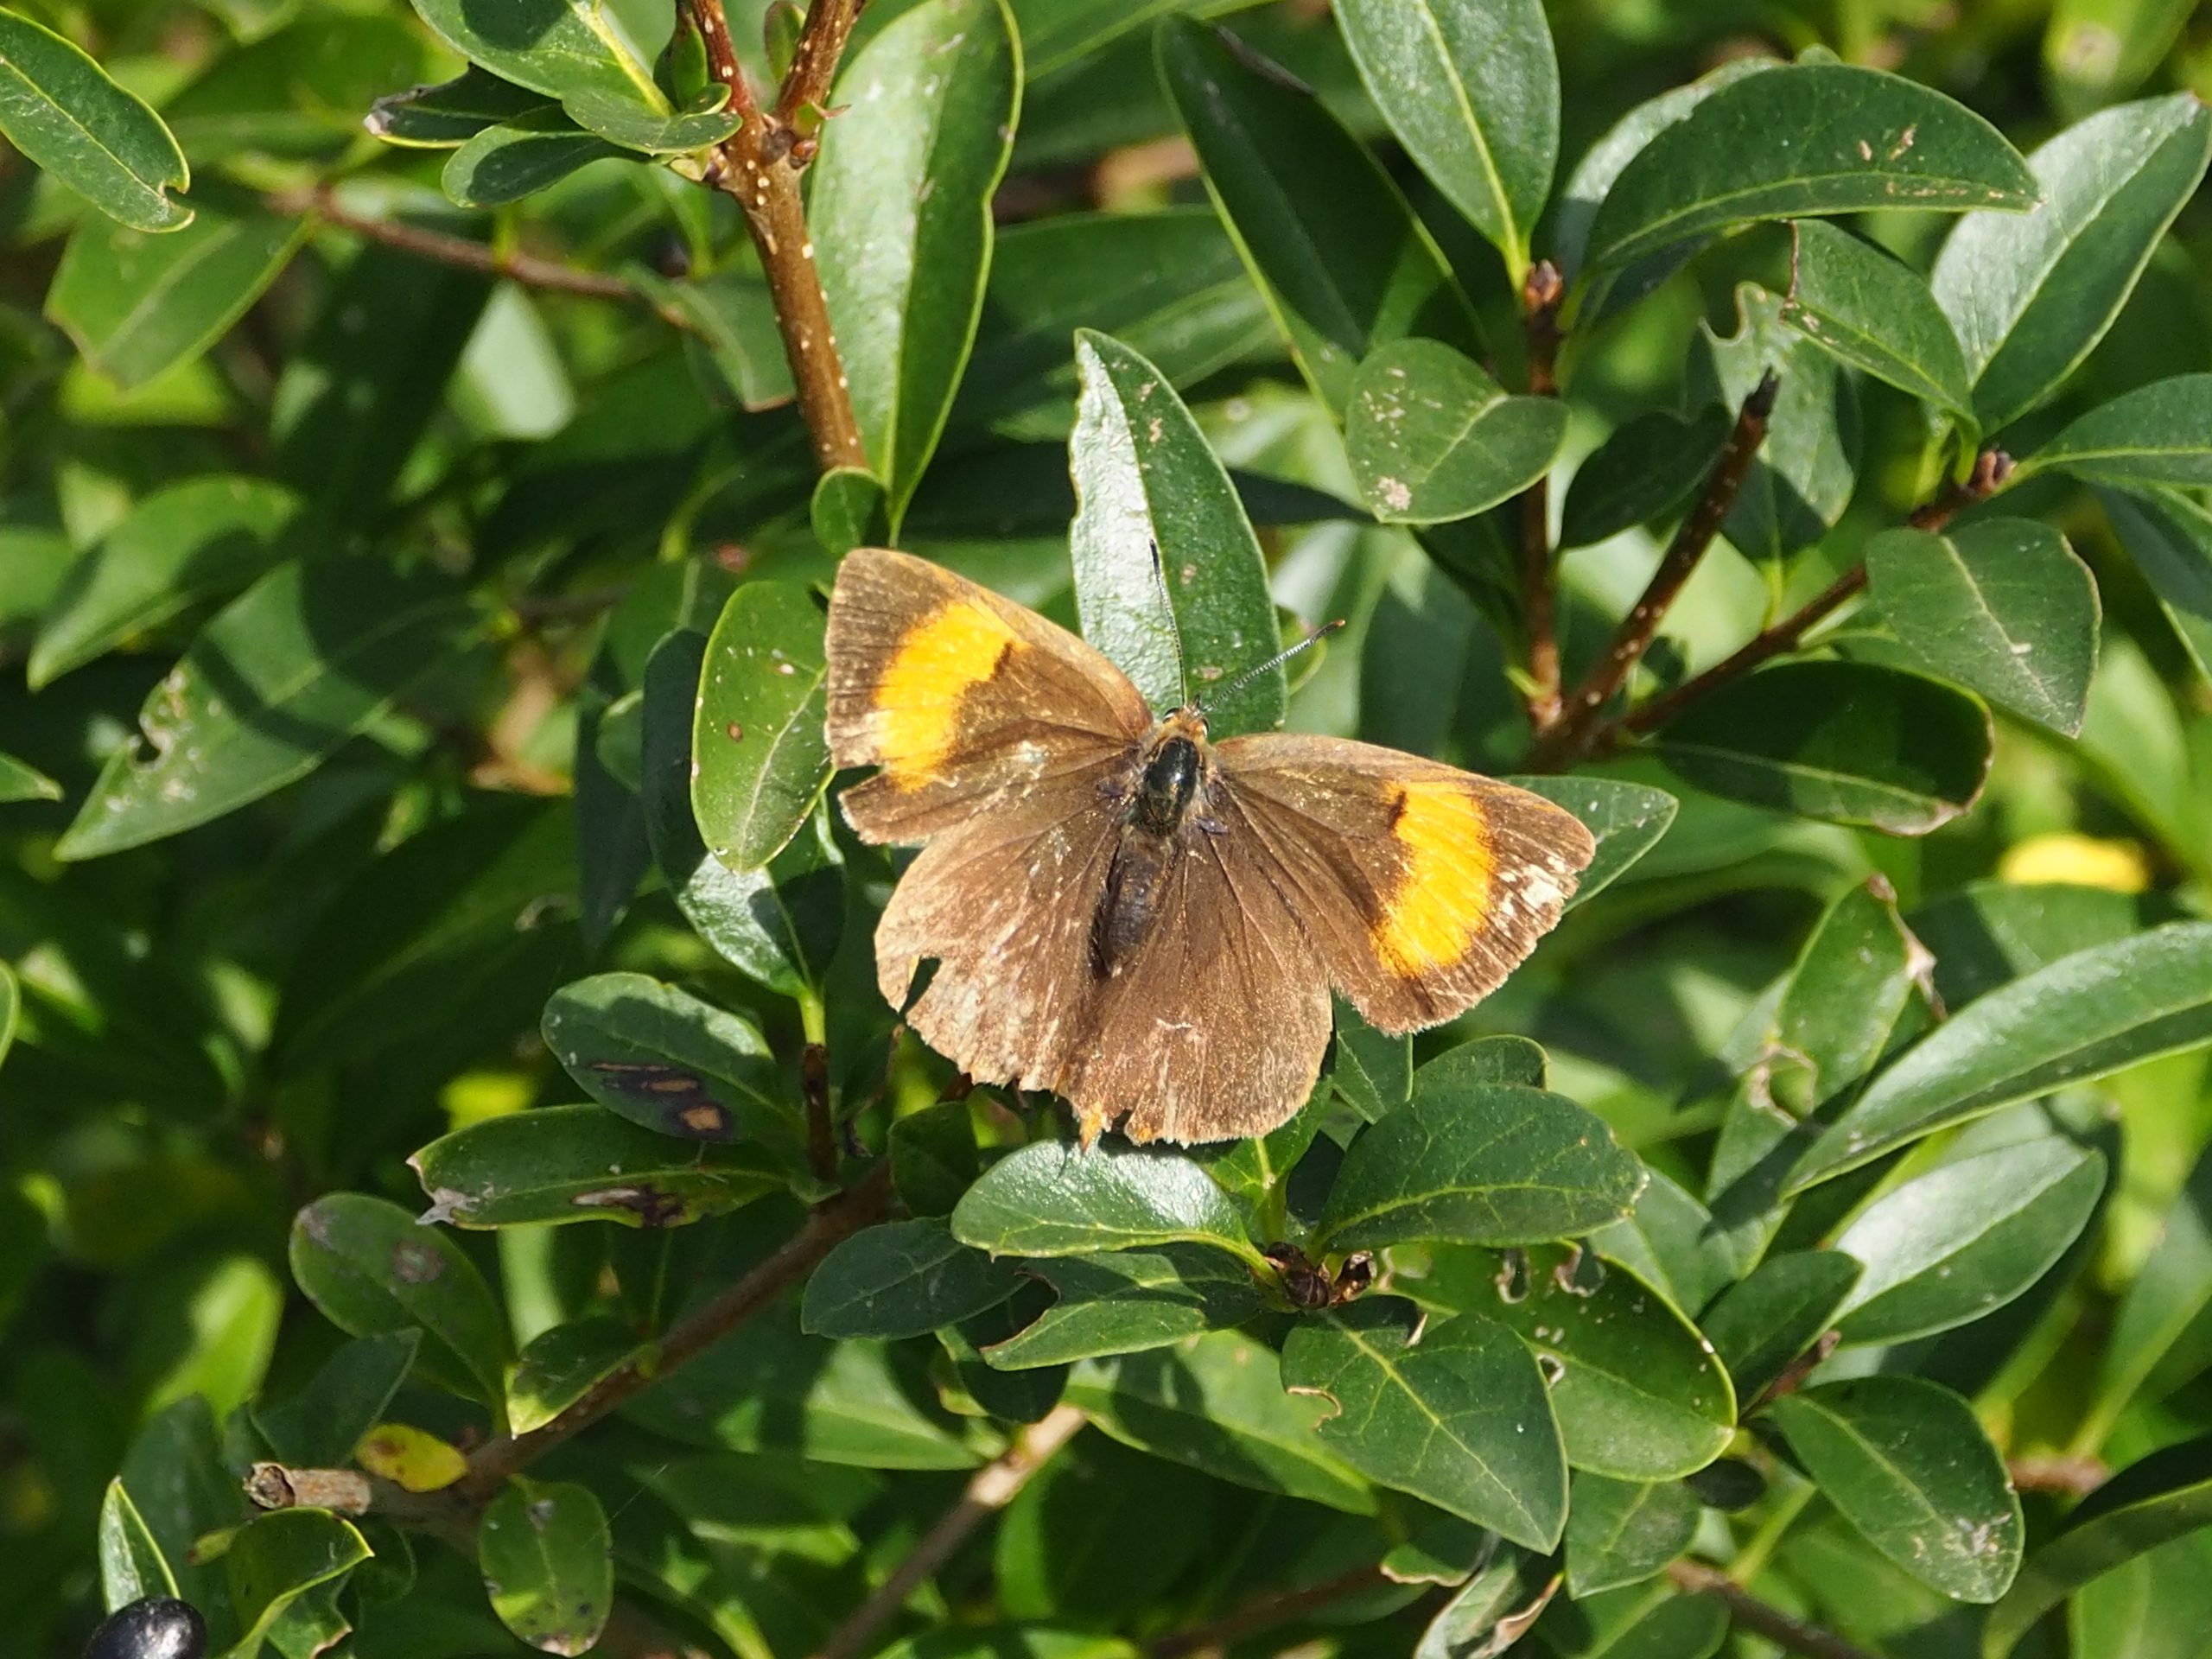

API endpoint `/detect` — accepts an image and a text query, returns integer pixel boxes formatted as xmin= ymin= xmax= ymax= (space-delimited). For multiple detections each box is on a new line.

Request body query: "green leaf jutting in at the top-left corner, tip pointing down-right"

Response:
xmin=0 ymin=11 xmax=193 ymax=230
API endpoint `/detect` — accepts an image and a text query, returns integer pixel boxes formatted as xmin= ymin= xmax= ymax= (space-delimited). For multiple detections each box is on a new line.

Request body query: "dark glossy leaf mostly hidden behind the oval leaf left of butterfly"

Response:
xmin=637 ymin=631 xmax=845 ymax=995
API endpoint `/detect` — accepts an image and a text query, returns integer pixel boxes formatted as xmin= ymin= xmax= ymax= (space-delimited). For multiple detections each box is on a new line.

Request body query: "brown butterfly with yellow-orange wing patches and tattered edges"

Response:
xmin=830 ymin=549 xmax=1595 ymax=1144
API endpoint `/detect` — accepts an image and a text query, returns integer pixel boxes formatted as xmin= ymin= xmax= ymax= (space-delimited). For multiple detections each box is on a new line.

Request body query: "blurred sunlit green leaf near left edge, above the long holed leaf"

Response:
xmin=27 ymin=475 xmax=301 ymax=690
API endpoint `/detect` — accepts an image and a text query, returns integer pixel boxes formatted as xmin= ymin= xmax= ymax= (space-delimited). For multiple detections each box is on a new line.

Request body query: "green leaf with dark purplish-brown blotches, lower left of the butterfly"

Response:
xmin=542 ymin=973 xmax=794 ymax=1146
